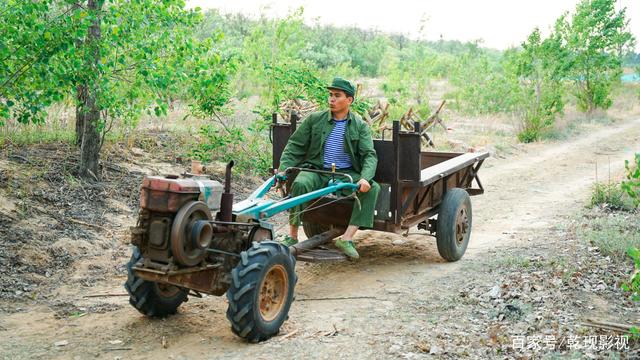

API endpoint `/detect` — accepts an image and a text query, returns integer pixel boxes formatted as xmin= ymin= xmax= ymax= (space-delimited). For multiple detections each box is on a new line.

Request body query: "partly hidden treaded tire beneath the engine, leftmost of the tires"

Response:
xmin=124 ymin=247 xmax=189 ymax=317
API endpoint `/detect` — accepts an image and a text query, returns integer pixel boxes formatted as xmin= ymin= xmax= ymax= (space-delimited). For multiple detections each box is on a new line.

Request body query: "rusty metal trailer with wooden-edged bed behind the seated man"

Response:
xmin=271 ymin=113 xmax=489 ymax=262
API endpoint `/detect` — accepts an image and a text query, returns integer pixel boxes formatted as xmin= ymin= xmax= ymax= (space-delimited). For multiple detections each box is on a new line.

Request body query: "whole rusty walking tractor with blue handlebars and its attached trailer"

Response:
xmin=125 ymin=118 xmax=488 ymax=342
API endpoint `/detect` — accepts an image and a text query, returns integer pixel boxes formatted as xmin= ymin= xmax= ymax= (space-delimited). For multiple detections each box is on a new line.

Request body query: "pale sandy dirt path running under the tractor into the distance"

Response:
xmin=0 ymin=119 xmax=640 ymax=359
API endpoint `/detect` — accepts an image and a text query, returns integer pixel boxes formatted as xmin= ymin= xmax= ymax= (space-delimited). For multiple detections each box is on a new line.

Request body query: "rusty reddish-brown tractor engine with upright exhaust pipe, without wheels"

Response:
xmin=131 ymin=162 xmax=273 ymax=295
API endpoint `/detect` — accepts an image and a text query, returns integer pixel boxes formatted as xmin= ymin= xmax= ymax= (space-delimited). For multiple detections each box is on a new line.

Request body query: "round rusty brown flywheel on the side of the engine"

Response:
xmin=171 ymin=201 xmax=213 ymax=266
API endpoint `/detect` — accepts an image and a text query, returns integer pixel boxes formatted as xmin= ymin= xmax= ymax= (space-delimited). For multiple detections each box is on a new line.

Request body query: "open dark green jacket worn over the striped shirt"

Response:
xmin=279 ymin=110 xmax=378 ymax=182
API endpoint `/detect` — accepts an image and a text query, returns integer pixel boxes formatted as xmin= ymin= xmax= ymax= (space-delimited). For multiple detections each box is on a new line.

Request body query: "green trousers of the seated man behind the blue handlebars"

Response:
xmin=289 ymin=169 xmax=380 ymax=228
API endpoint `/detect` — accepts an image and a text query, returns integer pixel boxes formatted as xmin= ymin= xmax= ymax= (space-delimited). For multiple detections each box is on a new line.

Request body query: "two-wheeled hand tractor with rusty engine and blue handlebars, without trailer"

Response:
xmin=125 ymin=162 xmax=358 ymax=342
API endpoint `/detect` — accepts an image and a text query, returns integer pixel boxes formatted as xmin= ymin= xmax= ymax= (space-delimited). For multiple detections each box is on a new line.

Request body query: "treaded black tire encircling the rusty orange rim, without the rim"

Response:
xmin=227 ymin=241 xmax=298 ymax=342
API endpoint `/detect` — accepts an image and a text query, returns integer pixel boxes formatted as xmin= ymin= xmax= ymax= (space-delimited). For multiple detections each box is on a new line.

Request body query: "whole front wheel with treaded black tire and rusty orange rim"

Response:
xmin=227 ymin=241 xmax=298 ymax=342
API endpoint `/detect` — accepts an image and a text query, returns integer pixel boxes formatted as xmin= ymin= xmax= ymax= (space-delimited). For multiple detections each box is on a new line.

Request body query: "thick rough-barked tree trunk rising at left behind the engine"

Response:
xmin=76 ymin=0 xmax=104 ymax=180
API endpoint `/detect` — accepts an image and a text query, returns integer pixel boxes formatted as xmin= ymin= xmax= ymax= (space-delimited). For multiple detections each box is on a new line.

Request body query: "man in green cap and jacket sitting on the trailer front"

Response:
xmin=279 ymin=77 xmax=380 ymax=259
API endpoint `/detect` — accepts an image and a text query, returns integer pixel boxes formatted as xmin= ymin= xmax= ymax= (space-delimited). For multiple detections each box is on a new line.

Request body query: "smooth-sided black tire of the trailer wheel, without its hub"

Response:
xmin=436 ymin=188 xmax=473 ymax=261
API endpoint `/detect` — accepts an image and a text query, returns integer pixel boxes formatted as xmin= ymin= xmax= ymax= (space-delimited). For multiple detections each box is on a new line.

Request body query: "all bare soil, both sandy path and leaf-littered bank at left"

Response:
xmin=0 ymin=116 xmax=640 ymax=359
